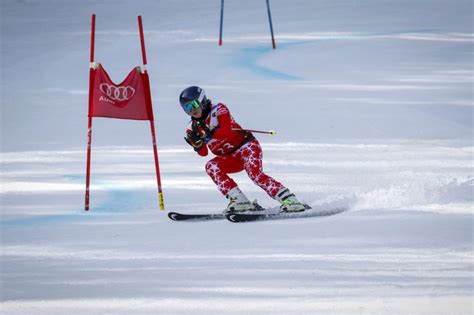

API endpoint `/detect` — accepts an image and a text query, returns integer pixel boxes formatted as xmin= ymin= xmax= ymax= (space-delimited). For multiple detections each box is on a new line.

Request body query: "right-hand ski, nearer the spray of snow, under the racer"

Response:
xmin=226 ymin=208 xmax=346 ymax=223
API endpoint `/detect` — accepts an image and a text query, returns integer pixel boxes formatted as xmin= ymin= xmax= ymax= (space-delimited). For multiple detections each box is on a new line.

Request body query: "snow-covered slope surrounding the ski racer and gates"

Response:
xmin=0 ymin=0 xmax=474 ymax=315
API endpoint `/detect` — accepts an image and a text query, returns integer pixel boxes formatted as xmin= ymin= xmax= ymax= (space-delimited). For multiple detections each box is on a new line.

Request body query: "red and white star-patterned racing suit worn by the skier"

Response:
xmin=187 ymin=103 xmax=283 ymax=198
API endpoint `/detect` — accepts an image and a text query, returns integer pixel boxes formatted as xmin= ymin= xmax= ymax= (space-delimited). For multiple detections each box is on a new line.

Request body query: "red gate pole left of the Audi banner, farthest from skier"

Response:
xmin=84 ymin=14 xmax=95 ymax=211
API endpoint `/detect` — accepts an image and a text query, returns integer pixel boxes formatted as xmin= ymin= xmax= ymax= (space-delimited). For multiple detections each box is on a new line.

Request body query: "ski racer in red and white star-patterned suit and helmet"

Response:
xmin=179 ymin=86 xmax=305 ymax=212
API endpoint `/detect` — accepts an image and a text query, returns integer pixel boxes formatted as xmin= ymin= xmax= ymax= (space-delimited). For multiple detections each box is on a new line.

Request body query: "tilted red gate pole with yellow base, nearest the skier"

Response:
xmin=138 ymin=15 xmax=165 ymax=210
